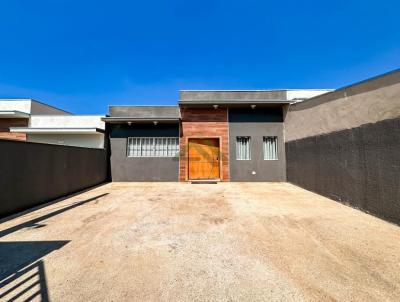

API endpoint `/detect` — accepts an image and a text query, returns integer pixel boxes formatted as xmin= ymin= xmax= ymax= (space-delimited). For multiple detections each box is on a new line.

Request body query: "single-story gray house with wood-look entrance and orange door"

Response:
xmin=103 ymin=90 xmax=330 ymax=181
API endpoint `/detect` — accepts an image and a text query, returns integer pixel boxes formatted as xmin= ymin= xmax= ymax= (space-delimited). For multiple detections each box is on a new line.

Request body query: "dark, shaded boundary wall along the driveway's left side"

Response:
xmin=0 ymin=140 xmax=107 ymax=217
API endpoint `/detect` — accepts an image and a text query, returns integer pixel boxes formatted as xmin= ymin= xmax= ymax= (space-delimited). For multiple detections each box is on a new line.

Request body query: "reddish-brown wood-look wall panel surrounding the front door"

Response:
xmin=179 ymin=108 xmax=229 ymax=181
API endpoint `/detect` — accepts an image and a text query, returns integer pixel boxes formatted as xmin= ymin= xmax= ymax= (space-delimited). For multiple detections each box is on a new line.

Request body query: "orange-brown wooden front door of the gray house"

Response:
xmin=188 ymin=138 xmax=220 ymax=180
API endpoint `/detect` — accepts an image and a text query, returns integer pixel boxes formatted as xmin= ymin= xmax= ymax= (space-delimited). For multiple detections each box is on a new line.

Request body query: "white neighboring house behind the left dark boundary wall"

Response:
xmin=0 ymin=99 xmax=105 ymax=148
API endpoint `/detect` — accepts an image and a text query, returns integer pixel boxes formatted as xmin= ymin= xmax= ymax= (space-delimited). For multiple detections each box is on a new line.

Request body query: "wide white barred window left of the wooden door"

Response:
xmin=127 ymin=137 xmax=179 ymax=157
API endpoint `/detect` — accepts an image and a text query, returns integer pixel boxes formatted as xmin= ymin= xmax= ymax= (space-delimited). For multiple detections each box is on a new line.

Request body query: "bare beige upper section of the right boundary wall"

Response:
xmin=285 ymin=71 xmax=400 ymax=142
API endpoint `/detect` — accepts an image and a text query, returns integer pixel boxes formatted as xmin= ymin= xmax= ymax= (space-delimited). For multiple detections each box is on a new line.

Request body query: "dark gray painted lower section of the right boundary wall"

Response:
xmin=286 ymin=118 xmax=400 ymax=224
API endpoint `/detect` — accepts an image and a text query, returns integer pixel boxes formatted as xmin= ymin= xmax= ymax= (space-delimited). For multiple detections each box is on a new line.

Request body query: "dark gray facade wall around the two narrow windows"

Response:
xmin=229 ymin=108 xmax=286 ymax=181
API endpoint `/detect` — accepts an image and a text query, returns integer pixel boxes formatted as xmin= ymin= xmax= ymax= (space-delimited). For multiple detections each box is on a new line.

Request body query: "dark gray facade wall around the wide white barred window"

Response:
xmin=109 ymin=124 xmax=179 ymax=181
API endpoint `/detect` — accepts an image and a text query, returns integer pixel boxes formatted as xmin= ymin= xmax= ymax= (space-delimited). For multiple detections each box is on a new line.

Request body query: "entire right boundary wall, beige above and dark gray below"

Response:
xmin=285 ymin=71 xmax=400 ymax=223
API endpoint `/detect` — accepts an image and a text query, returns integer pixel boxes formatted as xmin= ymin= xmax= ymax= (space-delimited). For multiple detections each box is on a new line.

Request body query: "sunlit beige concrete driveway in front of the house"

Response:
xmin=0 ymin=183 xmax=400 ymax=301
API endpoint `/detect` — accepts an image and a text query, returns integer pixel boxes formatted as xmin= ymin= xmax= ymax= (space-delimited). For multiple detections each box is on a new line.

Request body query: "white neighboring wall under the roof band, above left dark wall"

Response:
xmin=28 ymin=133 xmax=104 ymax=148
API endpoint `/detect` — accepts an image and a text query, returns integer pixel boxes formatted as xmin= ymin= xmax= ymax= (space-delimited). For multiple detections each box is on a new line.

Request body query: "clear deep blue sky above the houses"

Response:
xmin=0 ymin=0 xmax=400 ymax=114
